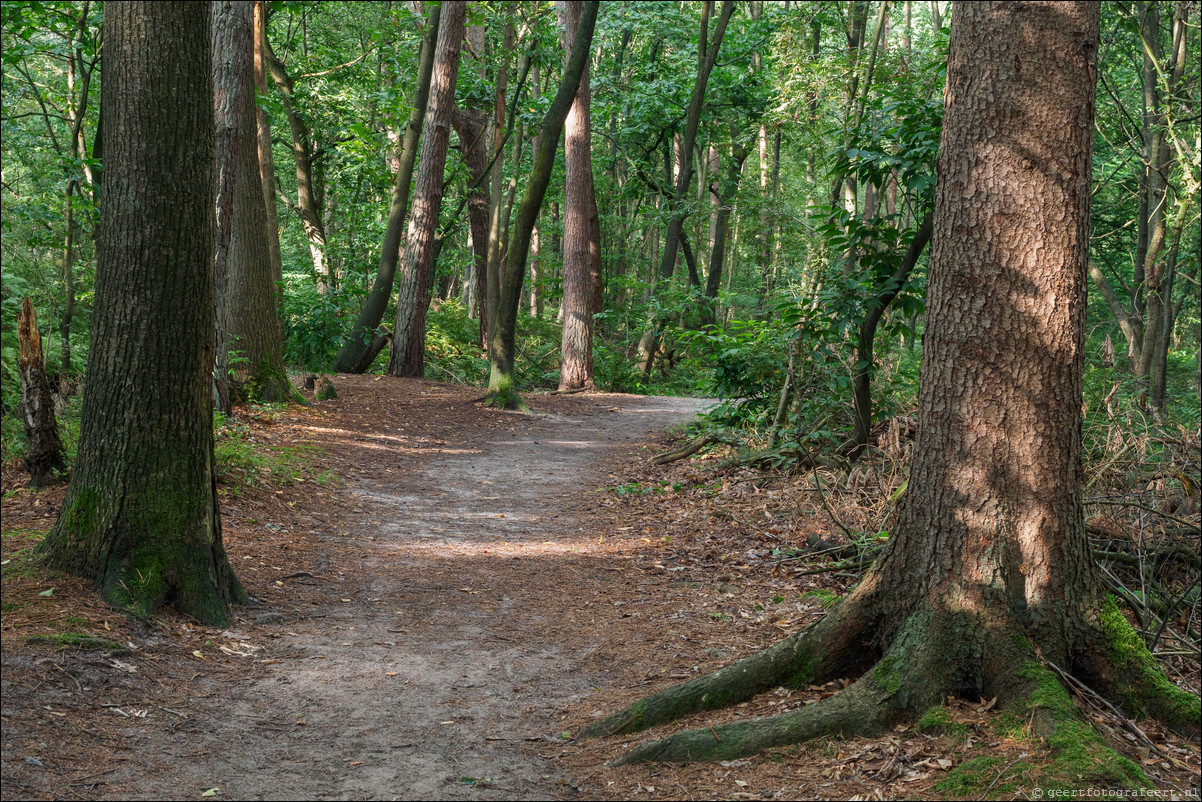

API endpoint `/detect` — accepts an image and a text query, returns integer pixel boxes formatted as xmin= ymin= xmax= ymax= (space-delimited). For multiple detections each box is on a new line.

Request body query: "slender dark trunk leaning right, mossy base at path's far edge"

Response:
xmin=488 ymin=0 xmax=599 ymax=409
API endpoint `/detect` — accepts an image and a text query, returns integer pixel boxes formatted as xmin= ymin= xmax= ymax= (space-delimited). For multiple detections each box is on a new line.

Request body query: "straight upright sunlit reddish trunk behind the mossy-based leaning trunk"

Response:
xmin=557 ymin=0 xmax=601 ymax=391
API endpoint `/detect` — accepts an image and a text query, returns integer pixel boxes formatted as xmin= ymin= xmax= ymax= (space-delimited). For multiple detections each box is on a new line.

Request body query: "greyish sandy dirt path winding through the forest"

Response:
xmin=134 ymin=378 xmax=706 ymax=800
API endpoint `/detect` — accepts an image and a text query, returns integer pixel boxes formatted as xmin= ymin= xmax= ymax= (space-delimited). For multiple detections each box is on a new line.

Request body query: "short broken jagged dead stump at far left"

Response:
xmin=17 ymin=298 xmax=67 ymax=489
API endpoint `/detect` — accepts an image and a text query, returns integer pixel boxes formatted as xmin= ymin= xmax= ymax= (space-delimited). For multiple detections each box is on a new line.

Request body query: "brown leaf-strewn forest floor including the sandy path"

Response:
xmin=0 ymin=376 xmax=1200 ymax=800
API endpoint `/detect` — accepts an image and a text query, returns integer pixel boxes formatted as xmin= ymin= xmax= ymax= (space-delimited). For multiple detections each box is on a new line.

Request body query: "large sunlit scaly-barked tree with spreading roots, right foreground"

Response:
xmin=585 ymin=2 xmax=1198 ymax=764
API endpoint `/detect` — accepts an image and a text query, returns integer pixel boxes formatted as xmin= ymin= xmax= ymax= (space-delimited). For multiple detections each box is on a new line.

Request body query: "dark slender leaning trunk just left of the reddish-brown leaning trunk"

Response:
xmin=334 ymin=5 xmax=442 ymax=373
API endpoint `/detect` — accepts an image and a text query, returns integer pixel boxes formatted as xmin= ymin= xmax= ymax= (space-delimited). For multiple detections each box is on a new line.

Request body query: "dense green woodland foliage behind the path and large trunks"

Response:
xmin=2 ymin=2 xmax=1200 ymax=432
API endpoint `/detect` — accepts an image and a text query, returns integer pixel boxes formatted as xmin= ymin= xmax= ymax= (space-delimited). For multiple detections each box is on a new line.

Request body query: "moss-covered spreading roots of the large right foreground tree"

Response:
xmin=582 ymin=584 xmax=1198 ymax=769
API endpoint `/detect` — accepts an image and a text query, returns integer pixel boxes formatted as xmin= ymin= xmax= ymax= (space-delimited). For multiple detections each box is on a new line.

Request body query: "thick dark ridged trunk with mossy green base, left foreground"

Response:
xmin=38 ymin=2 xmax=245 ymax=624
